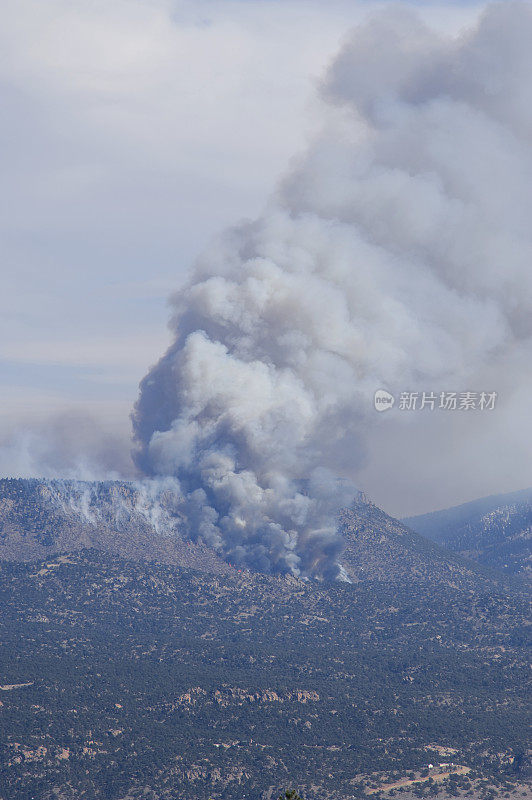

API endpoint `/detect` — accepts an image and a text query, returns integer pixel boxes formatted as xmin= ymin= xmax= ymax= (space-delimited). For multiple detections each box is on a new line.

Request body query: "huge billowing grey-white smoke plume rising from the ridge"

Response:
xmin=133 ymin=2 xmax=532 ymax=576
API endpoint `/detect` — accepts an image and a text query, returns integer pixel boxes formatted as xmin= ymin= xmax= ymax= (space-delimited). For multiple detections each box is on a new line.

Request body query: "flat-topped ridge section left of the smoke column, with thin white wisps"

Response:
xmin=0 ymin=478 xmax=232 ymax=572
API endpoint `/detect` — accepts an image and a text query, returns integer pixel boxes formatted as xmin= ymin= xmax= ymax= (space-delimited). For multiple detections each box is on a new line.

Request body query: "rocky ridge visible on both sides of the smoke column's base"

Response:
xmin=0 ymin=479 xmax=512 ymax=585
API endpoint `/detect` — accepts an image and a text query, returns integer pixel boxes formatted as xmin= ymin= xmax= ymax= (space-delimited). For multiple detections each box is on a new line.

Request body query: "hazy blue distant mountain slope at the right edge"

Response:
xmin=403 ymin=489 xmax=532 ymax=578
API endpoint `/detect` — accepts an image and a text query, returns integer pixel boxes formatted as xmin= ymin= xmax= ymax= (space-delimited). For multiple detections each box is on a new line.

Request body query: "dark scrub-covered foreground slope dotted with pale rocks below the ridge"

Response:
xmin=0 ymin=550 xmax=529 ymax=800
